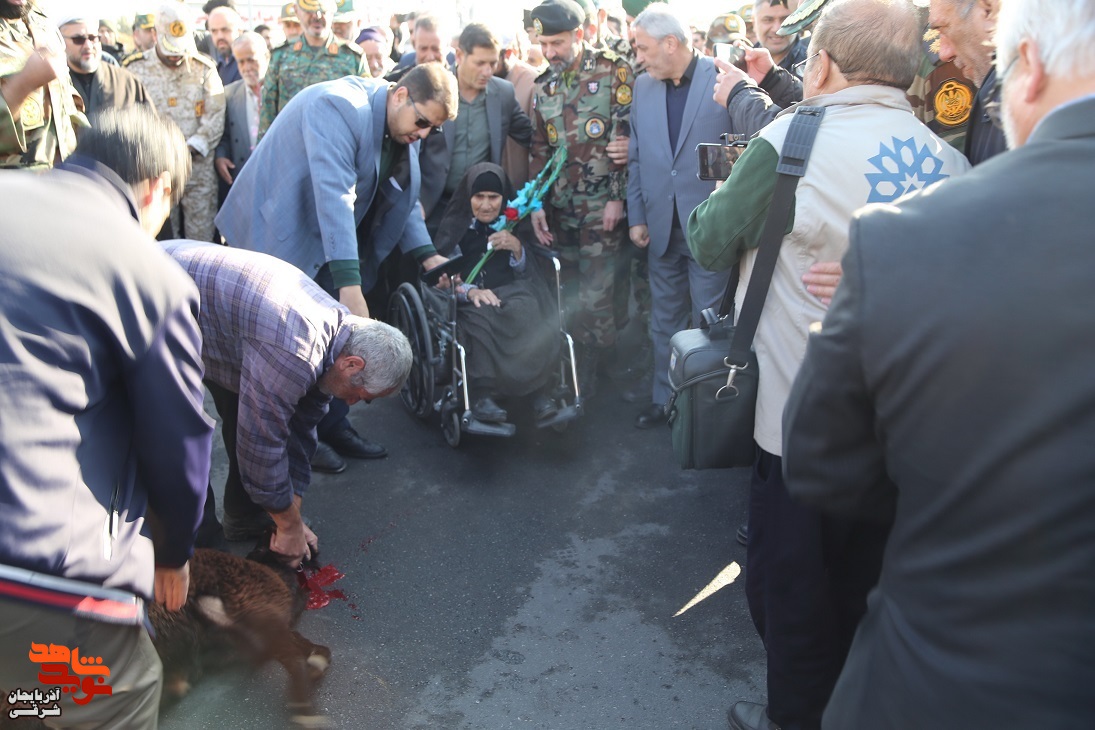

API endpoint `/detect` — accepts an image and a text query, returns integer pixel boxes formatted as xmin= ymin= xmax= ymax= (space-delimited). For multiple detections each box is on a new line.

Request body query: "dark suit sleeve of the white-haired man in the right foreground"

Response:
xmin=783 ymin=220 xmax=895 ymax=521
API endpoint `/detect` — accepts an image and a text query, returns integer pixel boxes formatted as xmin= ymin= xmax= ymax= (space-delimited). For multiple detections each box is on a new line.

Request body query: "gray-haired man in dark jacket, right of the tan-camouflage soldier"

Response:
xmin=214 ymin=31 xmax=270 ymax=205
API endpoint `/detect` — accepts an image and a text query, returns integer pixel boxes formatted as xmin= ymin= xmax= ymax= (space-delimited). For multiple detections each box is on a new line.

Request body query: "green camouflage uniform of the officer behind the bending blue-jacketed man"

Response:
xmin=258 ymin=34 xmax=370 ymax=139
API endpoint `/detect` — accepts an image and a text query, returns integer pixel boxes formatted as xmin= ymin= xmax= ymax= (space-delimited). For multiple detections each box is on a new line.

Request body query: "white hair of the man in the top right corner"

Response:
xmin=995 ymin=0 xmax=1095 ymax=78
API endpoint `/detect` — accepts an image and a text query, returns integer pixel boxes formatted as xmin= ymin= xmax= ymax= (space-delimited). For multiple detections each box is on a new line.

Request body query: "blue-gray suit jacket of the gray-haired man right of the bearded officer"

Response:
xmin=627 ymin=56 xmax=730 ymax=256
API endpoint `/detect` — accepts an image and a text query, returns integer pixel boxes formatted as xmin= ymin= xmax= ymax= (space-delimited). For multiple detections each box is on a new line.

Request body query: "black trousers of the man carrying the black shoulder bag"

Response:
xmin=746 ymin=449 xmax=889 ymax=730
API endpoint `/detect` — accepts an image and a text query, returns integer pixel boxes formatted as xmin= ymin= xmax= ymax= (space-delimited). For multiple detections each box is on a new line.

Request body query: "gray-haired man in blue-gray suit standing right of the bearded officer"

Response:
xmin=627 ymin=3 xmax=730 ymax=428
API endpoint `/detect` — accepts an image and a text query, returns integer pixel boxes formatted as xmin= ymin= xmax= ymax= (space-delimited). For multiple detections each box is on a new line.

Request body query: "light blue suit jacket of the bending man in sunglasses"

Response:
xmin=217 ymin=77 xmax=433 ymax=292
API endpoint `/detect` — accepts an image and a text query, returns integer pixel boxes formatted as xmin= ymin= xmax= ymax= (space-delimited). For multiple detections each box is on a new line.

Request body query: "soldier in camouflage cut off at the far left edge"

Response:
xmin=0 ymin=0 xmax=87 ymax=167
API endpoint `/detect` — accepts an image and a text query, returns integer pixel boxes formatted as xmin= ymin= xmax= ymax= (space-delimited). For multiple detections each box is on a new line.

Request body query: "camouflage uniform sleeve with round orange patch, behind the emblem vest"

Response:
xmin=906 ymin=49 xmax=977 ymax=152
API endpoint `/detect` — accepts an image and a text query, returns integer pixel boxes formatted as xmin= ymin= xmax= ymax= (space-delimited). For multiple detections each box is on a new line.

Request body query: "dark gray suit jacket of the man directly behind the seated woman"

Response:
xmin=419 ymin=78 xmax=532 ymax=216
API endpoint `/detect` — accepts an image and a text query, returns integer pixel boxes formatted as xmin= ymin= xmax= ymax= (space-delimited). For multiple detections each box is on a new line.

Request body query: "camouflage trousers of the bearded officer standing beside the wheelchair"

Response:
xmin=549 ymin=216 xmax=627 ymax=348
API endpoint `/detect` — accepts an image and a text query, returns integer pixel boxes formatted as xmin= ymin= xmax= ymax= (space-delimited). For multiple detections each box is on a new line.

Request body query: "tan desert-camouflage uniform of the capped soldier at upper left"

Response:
xmin=126 ymin=48 xmax=224 ymax=241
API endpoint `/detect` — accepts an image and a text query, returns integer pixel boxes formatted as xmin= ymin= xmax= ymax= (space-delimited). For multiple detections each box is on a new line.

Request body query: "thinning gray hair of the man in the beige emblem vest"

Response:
xmin=810 ymin=0 xmax=923 ymax=91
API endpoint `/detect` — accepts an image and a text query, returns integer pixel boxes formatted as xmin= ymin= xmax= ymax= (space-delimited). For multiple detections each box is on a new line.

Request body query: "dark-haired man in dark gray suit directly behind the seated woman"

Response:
xmin=418 ymin=23 xmax=532 ymax=236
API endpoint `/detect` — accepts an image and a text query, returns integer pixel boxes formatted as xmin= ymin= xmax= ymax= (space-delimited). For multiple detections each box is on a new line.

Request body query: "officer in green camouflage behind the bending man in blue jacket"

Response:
xmin=258 ymin=0 xmax=370 ymax=139
